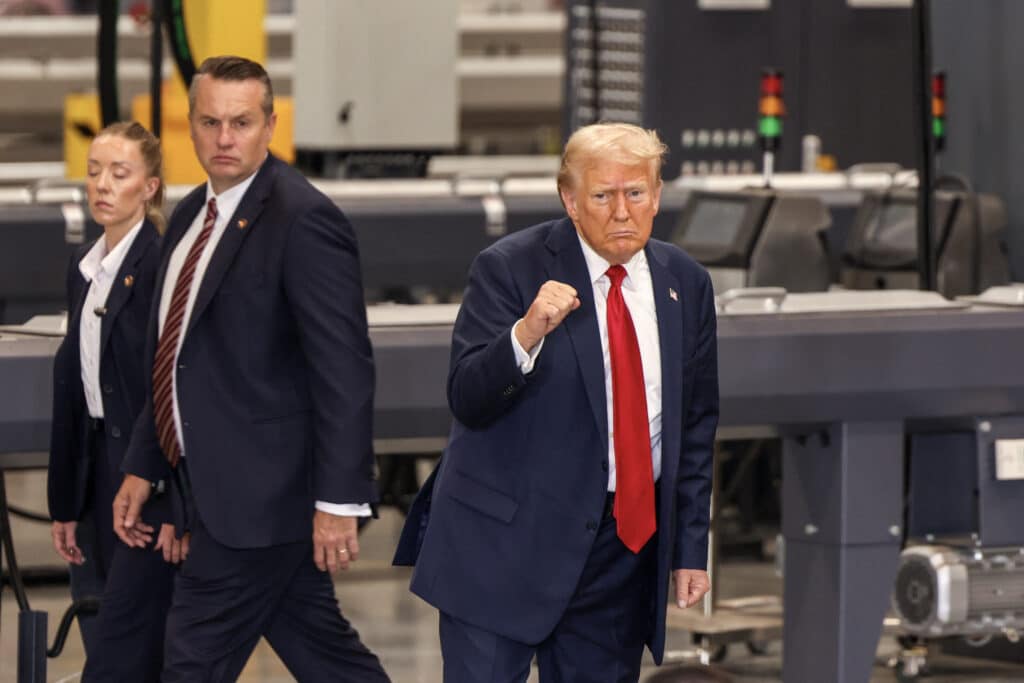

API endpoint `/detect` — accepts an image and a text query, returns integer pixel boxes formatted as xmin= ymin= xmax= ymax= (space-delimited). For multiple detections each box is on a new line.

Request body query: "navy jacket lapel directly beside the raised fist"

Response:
xmin=547 ymin=218 xmax=608 ymax=443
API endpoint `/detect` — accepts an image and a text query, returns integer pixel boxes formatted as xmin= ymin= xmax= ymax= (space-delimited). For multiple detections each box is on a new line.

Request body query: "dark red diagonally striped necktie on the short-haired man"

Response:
xmin=153 ymin=197 xmax=217 ymax=467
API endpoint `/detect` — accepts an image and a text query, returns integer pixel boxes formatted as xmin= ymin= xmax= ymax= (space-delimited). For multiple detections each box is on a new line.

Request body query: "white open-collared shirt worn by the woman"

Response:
xmin=78 ymin=219 xmax=144 ymax=420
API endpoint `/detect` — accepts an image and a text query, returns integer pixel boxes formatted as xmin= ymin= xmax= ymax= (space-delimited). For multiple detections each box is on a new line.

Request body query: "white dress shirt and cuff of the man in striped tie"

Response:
xmin=158 ymin=173 xmax=372 ymax=517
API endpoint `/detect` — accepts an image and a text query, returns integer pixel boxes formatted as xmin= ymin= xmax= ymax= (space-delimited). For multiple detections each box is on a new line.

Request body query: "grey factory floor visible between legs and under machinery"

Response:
xmin=0 ymin=472 xmax=1024 ymax=683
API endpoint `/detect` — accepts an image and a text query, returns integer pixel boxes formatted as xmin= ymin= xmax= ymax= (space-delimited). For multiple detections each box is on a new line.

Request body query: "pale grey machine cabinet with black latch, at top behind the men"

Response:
xmin=292 ymin=0 xmax=459 ymax=177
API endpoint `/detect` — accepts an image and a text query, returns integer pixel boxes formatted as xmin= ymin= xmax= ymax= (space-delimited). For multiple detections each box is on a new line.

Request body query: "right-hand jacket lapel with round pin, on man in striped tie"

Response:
xmin=185 ymin=156 xmax=281 ymax=335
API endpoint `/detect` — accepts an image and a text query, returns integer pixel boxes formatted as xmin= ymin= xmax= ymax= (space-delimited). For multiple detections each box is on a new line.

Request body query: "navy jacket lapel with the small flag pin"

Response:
xmin=645 ymin=243 xmax=687 ymax=502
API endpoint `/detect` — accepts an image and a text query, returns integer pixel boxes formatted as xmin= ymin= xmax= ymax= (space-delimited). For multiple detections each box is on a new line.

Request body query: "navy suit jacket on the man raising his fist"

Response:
xmin=395 ymin=218 xmax=718 ymax=661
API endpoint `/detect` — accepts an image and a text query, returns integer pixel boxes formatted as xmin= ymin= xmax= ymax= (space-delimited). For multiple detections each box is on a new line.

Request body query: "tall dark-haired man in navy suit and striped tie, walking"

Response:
xmin=114 ymin=56 xmax=388 ymax=683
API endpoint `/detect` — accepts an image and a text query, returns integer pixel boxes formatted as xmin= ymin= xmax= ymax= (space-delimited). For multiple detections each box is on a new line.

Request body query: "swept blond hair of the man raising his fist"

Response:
xmin=558 ymin=123 xmax=669 ymax=191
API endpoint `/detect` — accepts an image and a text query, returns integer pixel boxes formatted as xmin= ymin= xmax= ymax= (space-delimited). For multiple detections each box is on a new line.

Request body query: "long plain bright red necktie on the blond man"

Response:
xmin=607 ymin=265 xmax=656 ymax=553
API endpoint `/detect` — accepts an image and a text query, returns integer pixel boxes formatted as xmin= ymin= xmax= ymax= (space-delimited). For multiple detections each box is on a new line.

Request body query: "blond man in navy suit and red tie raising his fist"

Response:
xmin=395 ymin=124 xmax=718 ymax=683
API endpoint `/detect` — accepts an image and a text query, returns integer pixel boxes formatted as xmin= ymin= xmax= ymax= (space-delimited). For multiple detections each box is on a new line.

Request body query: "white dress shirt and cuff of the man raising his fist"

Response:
xmin=512 ymin=232 xmax=662 ymax=490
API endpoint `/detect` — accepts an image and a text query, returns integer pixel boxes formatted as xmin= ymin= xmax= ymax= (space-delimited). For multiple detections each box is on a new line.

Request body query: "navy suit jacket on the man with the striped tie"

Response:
xmin=124 ymin=156 xmax=377 ymax=548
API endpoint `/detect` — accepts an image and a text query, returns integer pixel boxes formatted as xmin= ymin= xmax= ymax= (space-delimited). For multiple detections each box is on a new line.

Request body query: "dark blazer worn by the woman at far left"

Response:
xmin=47 ymin=220 xmax=160 ymax=521
